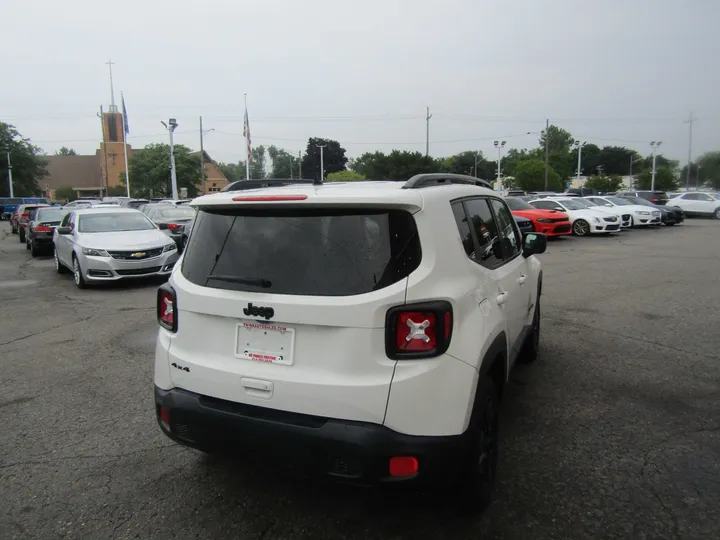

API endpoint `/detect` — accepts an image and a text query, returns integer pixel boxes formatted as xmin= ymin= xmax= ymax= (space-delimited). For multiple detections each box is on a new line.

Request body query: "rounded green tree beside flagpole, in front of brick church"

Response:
xmin=120 ymin=144 xmax=200 ymax=197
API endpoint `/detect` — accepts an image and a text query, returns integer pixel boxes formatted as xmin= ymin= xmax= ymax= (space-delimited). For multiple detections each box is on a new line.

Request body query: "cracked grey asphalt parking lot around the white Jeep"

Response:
xmin=0 ymin=220 xmax=720 ymax=540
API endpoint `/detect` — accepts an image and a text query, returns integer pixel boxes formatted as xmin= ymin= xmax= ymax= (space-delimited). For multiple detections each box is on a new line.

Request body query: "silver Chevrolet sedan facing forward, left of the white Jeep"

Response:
xmin=53 ymin=207 xmax=178 ymax=288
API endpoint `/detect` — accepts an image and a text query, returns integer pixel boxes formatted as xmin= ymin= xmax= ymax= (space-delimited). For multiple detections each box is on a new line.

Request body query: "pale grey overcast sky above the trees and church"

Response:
xmin=0 ymin=0 xmax=720 ymax=168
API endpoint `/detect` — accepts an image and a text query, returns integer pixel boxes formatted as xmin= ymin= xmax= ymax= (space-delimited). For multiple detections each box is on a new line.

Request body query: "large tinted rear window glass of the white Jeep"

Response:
xmin=182 ymin=208 xmax=421 ymax=296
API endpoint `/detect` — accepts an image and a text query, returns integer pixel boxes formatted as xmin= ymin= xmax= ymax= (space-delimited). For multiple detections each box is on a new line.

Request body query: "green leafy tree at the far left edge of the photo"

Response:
xmin=0 ymin=122 xmax=47 ymax=197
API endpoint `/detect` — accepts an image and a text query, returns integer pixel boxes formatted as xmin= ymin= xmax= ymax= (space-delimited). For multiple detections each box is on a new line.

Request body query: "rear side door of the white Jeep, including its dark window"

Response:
xmin=453 ymin=197 xmax=522 ymax=358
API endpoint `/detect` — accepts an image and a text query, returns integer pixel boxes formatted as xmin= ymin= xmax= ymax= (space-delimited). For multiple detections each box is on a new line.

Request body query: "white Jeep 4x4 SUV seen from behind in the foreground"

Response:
xmin=155 ymin=174 xmax=546 ymax=508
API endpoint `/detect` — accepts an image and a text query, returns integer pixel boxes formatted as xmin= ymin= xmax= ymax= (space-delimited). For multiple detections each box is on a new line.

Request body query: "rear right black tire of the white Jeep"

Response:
xmin=458 ymin=375 xmax=500 ymax=513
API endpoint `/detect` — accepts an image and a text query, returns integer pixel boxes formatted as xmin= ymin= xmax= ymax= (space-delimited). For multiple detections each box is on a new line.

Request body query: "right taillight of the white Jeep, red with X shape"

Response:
xmin=385 ymin=301 xmax=453 ymax=360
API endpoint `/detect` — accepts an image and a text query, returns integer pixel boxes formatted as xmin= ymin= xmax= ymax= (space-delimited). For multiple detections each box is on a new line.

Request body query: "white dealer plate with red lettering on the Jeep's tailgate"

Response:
xmin=235 ymin=321 xmax=295 ymax=366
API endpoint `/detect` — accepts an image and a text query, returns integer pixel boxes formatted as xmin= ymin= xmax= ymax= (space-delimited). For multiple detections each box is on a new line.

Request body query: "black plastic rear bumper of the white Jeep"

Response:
xmin=155 ymin=386 xmax=471 ymax=485
